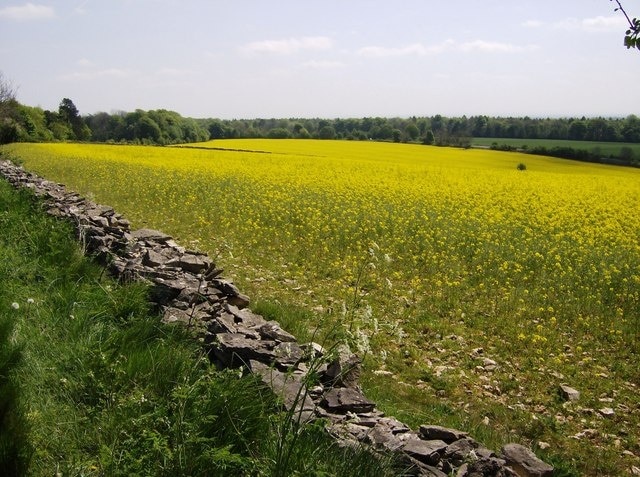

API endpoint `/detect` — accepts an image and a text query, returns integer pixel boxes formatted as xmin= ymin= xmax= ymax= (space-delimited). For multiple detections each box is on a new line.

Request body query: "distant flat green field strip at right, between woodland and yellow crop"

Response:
xmin=471 ymin=137 xmax=640 ymax=157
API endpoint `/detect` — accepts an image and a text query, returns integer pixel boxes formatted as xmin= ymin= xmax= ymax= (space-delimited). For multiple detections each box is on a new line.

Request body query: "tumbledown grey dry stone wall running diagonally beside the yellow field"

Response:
xmin=0 ymin=161 xmax=553 ymax=477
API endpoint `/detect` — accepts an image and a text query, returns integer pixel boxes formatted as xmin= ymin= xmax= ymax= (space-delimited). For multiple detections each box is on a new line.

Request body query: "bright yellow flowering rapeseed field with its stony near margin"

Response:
xmin=4 ymin=140 xmax=640 ymax=475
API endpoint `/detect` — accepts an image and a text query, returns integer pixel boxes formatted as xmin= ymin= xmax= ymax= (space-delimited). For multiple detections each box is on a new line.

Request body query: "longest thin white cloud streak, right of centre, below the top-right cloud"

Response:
xmin=358 ymin=40 xmax=536 ymax=58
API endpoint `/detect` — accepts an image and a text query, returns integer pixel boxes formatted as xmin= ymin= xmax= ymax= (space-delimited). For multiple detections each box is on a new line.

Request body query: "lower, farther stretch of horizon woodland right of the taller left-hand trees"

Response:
xmin=201 ymin=114 xmax=640 ymax=146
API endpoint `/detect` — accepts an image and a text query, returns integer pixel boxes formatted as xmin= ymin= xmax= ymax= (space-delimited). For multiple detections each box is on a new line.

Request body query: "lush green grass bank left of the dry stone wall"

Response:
xmin=0 ymin=176 xmax=396 ymax=477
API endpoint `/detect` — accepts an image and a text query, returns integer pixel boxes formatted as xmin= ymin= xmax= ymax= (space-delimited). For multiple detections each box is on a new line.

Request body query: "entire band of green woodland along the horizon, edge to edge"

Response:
xmin=0 ymin=94 xmax=640 ymax=165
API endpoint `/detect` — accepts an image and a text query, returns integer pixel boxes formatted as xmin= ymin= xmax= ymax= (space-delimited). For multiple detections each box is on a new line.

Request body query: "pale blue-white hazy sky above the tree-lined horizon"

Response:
xmin=0 ymin=0 xmax=640 ymax=119
